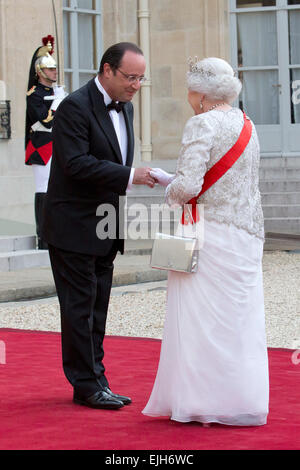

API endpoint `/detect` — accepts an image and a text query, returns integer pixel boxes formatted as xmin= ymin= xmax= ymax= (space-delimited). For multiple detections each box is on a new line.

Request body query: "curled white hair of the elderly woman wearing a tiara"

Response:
xmin=187 ymin=57 xmax=242 ymax=103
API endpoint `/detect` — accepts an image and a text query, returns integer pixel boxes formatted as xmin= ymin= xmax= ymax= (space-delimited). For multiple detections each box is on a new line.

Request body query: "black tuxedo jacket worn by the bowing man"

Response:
xmin=42 ymin=79 xmax=134 ymax=256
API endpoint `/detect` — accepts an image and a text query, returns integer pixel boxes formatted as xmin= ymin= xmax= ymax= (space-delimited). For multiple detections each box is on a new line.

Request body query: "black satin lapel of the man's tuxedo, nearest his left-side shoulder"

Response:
xmin=89 ymin=79 xmax=123 ymax=164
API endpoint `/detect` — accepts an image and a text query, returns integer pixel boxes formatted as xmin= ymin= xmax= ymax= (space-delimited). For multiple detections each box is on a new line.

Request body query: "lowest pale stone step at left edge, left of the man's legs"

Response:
xmin=0 ymin=250 xmax=50 ymax=272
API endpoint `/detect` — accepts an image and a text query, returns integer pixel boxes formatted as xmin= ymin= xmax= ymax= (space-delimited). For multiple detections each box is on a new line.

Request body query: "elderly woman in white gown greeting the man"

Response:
xmin=143 ymin=58 xmax=269 ymax=426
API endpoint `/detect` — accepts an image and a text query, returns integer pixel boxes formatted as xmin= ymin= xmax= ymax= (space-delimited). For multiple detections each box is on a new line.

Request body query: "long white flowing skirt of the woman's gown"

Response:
xmin=142 ymin=109 xmax=269 ymax=426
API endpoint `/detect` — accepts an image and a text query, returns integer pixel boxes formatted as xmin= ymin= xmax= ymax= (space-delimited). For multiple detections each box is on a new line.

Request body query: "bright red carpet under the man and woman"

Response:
xmin=0 ymin=329 xmax=300 ymax=450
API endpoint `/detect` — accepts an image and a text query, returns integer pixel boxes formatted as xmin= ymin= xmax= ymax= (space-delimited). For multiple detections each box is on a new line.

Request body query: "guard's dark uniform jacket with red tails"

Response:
xmin=25 ymin=83 xmax=54 ymax=165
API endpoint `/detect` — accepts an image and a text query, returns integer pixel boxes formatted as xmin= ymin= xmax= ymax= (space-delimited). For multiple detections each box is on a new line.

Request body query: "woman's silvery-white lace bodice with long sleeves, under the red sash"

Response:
xmin=166 ymin=108 xmax=264 ymax=239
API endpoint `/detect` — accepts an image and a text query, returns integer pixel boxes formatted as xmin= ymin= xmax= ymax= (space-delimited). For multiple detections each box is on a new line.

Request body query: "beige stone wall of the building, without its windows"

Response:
xmin=0 ymin=0 xmax=229 ymax=234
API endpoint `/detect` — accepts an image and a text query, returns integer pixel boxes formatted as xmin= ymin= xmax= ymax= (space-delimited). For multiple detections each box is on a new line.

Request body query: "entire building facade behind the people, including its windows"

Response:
xmin=0 ymin=0 xmax=300 ymax=235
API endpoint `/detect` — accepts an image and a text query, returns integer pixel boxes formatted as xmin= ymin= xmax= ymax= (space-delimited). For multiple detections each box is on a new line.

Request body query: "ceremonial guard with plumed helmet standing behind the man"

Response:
xmin=25 ymin=35 xmax=66 ymax=249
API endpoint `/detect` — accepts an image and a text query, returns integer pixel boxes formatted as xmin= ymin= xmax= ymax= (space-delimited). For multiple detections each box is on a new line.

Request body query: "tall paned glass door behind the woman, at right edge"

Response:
xmin=230 ymin=0 xmax=300 ymax=156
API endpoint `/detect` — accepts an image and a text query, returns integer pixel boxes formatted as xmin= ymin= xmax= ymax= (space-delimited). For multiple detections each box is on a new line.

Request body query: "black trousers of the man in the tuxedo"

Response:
xmin=49 ymin=243 xmax=117 ymax=396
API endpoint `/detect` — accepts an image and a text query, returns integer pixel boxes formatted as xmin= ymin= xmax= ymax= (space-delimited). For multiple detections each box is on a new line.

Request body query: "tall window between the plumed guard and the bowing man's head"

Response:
xmin=63 ymin=0 xmax=102 ymax=92
